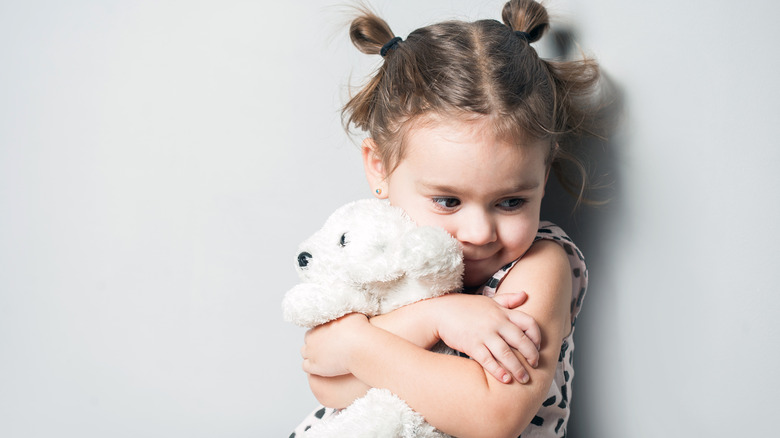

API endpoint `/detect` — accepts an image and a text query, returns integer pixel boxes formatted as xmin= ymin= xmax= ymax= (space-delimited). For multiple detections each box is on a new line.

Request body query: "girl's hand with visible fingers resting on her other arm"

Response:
xmin=436 ymin=292 xmax=541 ymax=383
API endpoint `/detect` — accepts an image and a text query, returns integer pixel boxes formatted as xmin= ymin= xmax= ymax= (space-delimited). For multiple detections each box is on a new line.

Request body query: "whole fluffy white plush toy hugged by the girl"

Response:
xmin=282 ymin=199 xmax=463 ymax=438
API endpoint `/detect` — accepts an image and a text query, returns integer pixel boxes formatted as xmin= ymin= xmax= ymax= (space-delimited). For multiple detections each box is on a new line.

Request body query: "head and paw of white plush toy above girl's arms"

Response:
xmin=282 ymin=199 xmax=463 ymax=327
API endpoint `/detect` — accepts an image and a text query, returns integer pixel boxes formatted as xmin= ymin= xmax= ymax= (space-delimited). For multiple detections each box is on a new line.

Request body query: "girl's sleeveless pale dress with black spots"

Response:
xmin=290 ymin=221 xmax=588 ymax=438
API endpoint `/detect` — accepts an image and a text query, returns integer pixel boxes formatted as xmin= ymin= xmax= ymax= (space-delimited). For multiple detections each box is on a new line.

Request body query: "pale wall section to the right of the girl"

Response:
xmin=573 ymin=0 xmax=780 ymax=437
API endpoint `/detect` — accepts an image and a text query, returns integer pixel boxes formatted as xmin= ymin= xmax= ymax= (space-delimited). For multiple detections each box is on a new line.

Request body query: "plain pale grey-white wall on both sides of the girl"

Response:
xmin=0 ymin=0 xmax=780 ymax=438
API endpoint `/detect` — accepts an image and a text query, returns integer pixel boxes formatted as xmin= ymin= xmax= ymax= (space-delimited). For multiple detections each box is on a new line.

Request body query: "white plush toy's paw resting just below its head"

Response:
xmin=282 ymin=283 xmax=377 ymax=328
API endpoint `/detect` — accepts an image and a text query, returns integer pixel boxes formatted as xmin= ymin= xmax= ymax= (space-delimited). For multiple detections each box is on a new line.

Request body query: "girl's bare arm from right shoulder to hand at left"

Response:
xmin=303 ymin=241 xmax=571 ymax=437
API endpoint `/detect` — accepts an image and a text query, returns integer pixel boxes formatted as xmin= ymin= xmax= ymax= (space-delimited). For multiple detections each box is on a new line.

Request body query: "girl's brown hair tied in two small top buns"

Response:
xmin=342 ymin=0 xmax=599 ymax=202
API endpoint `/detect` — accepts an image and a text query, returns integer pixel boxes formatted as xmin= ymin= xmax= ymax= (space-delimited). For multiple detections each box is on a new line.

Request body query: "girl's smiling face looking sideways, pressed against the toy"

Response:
xmin=363 ymin=116 xmax=548 ymax=286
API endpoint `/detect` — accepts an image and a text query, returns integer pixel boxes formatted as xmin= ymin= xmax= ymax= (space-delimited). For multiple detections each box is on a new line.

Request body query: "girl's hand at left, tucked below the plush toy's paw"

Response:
xmin=301 ymin=313 xmax=369 ymax=377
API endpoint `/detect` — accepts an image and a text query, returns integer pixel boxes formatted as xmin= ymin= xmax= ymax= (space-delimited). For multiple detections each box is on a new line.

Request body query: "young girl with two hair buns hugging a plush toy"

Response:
xmin=291 ymin=0 xmax=598 ymax=438
